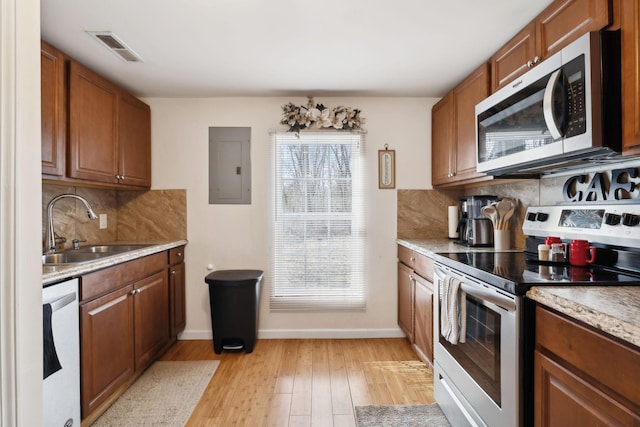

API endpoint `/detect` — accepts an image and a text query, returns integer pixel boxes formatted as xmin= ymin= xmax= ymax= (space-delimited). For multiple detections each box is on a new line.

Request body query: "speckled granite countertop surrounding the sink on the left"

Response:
xmin=42 ymin=240 xmax=187 ymax=286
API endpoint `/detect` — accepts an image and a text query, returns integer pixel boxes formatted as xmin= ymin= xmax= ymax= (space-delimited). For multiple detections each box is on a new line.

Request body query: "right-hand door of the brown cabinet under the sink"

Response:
xmin=134 ymin=270 xmax=169 ymax=370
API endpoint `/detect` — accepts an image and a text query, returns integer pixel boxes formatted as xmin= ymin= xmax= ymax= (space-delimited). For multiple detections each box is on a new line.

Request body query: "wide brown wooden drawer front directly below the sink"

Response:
xmin=80 ymin=251 xmax=167 ymax=302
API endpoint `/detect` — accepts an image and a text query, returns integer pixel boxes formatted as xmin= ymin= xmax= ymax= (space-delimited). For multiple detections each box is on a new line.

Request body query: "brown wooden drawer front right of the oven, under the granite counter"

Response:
xmin=536 ymin=306 xmax=640 ymax=405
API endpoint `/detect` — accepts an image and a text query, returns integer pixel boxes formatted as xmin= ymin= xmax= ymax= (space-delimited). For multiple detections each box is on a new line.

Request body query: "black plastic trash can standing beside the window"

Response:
xmin=204 ymin=270 xmax=264 ymax=354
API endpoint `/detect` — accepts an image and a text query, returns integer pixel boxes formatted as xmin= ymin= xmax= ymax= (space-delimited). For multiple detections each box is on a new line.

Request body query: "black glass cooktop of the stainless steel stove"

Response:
xmin=434 ymin=251 xmax=640 ymax=295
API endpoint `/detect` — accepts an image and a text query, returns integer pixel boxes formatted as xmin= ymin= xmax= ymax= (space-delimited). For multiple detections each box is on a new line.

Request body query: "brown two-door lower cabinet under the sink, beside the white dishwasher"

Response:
xmin=80 ymin=251 xmax=184 ymax=424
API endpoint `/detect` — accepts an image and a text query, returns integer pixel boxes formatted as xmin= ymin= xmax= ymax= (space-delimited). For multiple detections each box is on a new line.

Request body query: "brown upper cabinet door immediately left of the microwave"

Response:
xmin=453 ymin=63 xmax=489 ymax=181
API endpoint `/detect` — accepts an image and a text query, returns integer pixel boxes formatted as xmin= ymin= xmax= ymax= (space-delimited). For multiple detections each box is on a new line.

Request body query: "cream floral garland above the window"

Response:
xmin=280 ymin=96 xmax=364 ymax=133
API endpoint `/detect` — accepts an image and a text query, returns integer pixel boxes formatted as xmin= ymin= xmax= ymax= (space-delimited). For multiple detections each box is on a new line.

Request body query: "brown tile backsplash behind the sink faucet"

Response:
xmin=42 ymin=184 xmax=187 ymax=248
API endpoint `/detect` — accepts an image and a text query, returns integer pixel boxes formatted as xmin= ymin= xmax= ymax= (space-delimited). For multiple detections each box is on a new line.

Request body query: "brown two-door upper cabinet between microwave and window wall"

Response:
xmin=431 ymin=63 xmax=491 ymax=187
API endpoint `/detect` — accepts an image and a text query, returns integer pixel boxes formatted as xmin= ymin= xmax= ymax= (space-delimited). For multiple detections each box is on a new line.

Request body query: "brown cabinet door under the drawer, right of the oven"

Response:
xmin=534 ymin=351 xmax=640 ymax=427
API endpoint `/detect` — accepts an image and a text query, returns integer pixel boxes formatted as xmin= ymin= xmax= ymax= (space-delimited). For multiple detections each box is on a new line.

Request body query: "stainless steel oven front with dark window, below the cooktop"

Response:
xmin=434 ymin=263 xmax=522 ymax=426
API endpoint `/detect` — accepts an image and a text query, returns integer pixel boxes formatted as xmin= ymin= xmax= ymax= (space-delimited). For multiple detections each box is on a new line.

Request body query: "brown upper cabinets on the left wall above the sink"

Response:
xmin=42 ymin=44 xmax=151 ymax=188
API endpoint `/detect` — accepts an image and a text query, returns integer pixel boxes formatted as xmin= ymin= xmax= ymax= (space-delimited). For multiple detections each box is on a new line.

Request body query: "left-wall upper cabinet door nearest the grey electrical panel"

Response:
xmin=118 ymin=94 xmax=151 ymax=187
